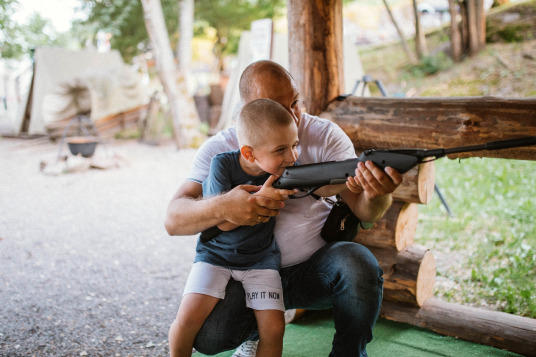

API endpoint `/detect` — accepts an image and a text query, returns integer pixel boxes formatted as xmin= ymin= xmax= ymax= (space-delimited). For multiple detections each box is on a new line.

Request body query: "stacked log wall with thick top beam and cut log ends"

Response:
xmin=320 ymin=97 xmax=536 ymax=356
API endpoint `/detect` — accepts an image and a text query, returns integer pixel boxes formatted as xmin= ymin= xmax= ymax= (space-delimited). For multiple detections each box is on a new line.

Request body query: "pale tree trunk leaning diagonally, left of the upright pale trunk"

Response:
xmin=141 ymin=0 xmax=202 ymax=148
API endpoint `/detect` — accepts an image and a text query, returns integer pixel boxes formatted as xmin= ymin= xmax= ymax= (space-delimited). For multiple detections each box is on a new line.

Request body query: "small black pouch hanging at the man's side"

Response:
xmin=320 ymin=196 xmax=361 ymax=243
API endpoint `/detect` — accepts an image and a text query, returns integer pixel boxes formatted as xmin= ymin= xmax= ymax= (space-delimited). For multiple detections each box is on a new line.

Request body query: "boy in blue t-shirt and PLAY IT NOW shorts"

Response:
xmin=169 ymin=99 xmax=298 ymax=357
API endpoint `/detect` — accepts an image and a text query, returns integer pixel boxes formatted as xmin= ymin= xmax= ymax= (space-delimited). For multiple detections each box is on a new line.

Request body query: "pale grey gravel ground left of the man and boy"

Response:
xmin=0 ymin=138 xmax=195 ymax=357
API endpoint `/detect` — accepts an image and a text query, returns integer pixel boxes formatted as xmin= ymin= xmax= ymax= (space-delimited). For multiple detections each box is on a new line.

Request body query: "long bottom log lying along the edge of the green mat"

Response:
xmin=380 ymin=298 xmax=536 ymax=356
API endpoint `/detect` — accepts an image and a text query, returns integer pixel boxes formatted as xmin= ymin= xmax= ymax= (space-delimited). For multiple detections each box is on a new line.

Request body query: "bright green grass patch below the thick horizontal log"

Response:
xmin=416 ymin=158 xmax=536 ymax=318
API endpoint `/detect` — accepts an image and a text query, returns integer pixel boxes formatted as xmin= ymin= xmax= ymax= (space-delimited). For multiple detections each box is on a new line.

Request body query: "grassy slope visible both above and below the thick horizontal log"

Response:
xmin=360 ymin=1 xmax=536 ymax=318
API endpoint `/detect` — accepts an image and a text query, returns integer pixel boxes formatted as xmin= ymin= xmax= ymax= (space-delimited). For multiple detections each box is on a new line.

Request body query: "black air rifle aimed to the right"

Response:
xmin=273 ymin=136 xmax=536 ymax=198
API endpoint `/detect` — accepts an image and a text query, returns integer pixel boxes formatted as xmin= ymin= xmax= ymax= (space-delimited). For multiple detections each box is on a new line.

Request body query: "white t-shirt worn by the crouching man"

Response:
xmin=188 ymin=114 xmax=356 ymax=267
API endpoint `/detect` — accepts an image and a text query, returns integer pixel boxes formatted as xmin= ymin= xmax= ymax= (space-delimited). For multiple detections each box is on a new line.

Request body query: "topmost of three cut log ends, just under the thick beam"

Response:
xmin=393 ymin=161 xmax=435 ymax=204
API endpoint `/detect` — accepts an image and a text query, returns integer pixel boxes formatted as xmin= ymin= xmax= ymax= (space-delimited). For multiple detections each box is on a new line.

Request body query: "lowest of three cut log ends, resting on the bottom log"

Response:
xmin=369 ymin=245 xmax=436 ymax=306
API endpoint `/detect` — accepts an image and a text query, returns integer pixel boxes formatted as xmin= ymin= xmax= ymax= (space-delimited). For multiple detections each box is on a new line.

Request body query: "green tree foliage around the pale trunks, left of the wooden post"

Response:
xmin=77 ymin=0 xmax=284 ymax=65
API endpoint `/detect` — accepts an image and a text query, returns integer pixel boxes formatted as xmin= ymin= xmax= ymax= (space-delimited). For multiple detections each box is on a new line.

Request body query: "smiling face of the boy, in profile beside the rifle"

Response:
xmin=253 ymin=123 xmax=298 ymax=175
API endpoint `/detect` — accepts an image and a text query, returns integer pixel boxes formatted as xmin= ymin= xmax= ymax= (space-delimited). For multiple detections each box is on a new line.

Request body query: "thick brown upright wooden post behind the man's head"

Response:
xmin=287 ymin=0 xmax=344 ymax=115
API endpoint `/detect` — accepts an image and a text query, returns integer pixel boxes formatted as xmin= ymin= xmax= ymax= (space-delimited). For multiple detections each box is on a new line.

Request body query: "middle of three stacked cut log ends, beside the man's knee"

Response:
xmin=354 ymin=201 xmax=418 ymax=252
